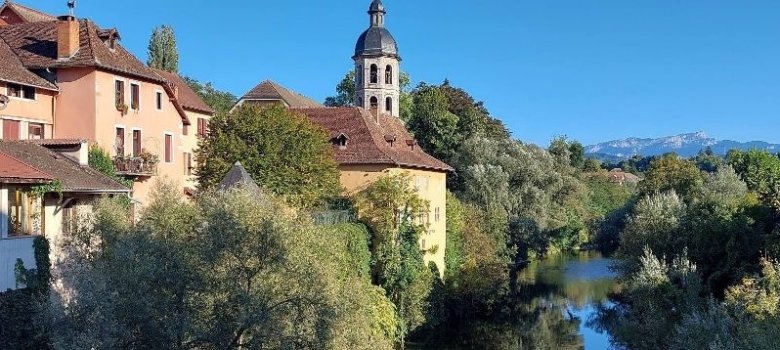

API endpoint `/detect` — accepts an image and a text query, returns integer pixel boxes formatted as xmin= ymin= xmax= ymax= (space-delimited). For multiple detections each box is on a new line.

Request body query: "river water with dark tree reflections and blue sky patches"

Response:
xmin=409 ymin=253 xmax=617 ymax=350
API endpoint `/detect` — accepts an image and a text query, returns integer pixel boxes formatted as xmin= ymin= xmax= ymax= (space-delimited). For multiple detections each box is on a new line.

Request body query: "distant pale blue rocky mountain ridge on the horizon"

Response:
xmin=585 ymin=132 xmax=780 ymax=161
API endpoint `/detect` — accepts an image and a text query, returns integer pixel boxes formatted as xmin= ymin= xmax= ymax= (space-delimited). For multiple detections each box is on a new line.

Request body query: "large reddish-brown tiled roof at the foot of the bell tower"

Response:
xmin=293 ymin=107 xmax=453 ymax=171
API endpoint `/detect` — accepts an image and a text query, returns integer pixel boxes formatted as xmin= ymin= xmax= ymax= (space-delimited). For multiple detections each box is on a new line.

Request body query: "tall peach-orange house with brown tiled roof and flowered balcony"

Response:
xmin=0 ymin=3 xmax=213 ymax=207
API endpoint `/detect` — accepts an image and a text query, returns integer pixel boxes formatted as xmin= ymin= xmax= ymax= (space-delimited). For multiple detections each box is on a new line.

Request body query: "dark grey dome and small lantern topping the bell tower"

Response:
xmin=355 ymin=0 xmax=398 ymax=57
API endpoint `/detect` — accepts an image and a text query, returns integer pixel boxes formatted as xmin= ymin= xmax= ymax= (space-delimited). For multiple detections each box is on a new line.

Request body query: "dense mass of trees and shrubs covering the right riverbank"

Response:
xmin=599 ymin=150 xmax=780 ymax=349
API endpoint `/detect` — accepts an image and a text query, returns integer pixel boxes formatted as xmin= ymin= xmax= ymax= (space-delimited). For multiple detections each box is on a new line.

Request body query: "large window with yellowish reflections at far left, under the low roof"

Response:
xmin=8 ymin=188 xmax=44 ymax=237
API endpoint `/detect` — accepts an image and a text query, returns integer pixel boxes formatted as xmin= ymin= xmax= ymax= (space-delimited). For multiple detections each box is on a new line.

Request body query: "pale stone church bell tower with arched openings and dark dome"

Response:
xmin=352 ymin=0 xmax=401 ymax=118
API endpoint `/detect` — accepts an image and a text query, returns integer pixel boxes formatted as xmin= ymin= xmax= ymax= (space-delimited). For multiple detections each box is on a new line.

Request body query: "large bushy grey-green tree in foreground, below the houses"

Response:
xmin=48 ymin=184 xmax=394 ymax=350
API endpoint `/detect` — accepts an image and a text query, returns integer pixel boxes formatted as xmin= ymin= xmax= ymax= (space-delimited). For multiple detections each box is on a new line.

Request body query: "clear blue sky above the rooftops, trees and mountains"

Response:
xmin=27 ymin=0 xmax=780 ymax=145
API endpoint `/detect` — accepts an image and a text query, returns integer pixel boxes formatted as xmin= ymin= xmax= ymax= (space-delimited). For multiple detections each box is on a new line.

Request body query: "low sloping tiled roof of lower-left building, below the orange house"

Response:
xmin=0 ymin=140 xmax=130 ymax=193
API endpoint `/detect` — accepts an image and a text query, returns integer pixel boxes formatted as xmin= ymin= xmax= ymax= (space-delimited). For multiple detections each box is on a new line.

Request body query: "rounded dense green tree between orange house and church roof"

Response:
xmin=195 ymin=106 xmax=340 ymax=207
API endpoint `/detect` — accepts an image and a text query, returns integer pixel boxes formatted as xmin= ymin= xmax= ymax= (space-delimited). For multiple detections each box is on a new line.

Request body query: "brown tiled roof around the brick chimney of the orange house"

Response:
xmin=0 ymin=19 xmax=164 ymax=83
